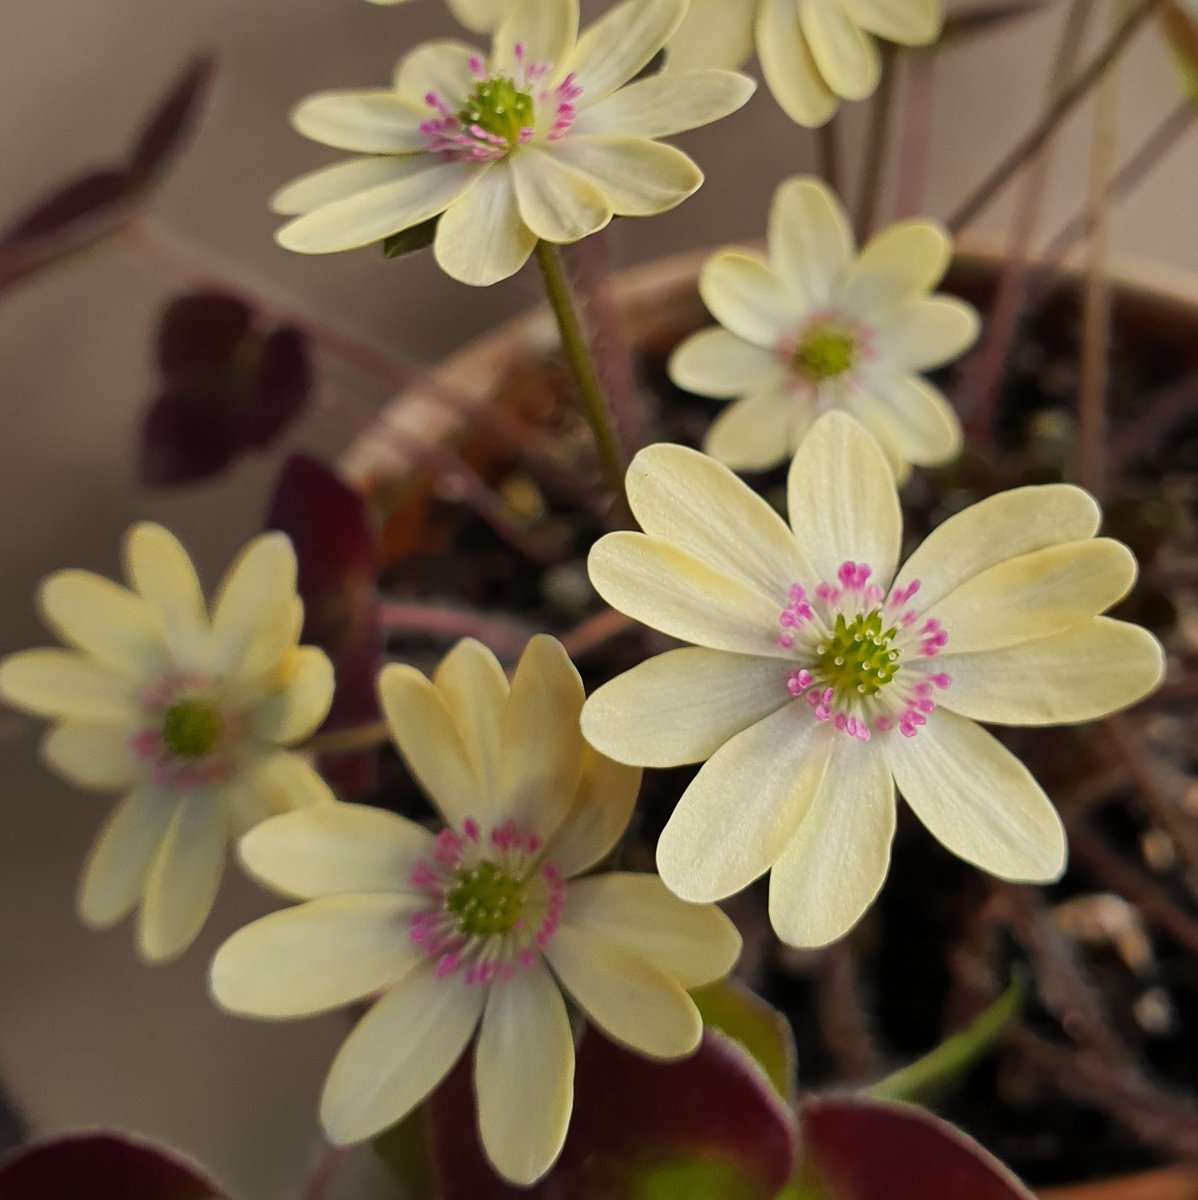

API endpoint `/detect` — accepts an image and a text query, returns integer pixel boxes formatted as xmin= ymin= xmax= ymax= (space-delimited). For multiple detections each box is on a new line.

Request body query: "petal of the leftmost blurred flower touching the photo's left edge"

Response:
xmin=0 ymin=648 xmax=143 ymax=731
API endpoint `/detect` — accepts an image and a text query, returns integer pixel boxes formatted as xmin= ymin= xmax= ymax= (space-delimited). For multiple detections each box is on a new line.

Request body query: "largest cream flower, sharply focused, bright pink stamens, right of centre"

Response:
xmin=582 ymin=413 xmax=1162 ymax=946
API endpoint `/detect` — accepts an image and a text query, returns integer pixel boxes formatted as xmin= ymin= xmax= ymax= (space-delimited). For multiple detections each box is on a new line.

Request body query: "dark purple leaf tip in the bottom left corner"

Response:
xmin=0 ymin=1133 xmax=224 ymax=1200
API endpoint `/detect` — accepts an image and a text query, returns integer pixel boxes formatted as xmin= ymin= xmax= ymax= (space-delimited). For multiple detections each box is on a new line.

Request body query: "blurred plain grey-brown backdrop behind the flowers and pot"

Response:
xmin=0 ymin=0 xmax=1198 ymax=1200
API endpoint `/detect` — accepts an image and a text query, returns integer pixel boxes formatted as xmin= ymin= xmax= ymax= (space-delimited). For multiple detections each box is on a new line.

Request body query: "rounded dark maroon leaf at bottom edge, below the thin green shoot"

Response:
xmin=799 ymin=1097 xmax=1032 ymax=1200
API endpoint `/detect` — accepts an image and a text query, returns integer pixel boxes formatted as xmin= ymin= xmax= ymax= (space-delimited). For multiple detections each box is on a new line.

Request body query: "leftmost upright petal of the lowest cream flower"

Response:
xmin=378 ymin=662 xmax=482 ymax=828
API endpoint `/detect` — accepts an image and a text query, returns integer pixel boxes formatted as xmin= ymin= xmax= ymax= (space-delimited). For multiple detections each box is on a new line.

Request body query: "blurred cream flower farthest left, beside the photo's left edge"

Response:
xmin=0 ymin=523 xmax=333 ymax=962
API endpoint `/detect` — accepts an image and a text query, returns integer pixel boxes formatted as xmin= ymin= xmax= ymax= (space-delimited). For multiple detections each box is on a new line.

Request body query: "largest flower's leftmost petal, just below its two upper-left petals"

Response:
xmin=582 ymin=647 xmax=791 ymax=767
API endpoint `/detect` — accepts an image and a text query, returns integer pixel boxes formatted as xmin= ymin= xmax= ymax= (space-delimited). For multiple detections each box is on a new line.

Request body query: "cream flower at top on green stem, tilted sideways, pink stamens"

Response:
xmin=272 ymin=0 xmax=754 ymax=284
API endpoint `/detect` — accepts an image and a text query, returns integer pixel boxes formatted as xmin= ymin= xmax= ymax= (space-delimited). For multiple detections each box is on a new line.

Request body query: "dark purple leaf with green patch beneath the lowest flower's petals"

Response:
xmin=430 ymin=1027 xmax=797 ymax=1200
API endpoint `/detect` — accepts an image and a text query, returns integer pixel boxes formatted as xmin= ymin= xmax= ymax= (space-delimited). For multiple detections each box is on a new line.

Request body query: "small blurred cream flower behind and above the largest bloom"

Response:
xmin=670 ymin=176 xmax=978 ymax=479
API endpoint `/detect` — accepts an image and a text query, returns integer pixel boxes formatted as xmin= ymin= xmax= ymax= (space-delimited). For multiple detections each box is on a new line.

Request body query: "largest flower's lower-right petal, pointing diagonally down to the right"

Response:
xmin=886 ymin=710 xmax=1066 ymax=883
